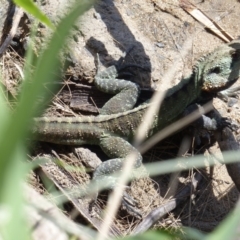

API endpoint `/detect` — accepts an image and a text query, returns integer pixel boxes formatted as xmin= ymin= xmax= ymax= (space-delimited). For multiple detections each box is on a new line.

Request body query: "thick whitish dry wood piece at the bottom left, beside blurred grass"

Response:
xmin=24 ymin=185 xmax=96 ymax=240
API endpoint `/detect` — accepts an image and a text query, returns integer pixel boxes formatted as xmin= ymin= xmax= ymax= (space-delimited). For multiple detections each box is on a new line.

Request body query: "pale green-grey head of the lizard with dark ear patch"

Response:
xmin=195 ymin=41 xmax=240 ymax=92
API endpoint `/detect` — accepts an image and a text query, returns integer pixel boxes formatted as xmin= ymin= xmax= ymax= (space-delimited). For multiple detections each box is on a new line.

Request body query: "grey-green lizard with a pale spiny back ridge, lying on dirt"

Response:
xmin=32 ymin=41 xmax=240 ymax=216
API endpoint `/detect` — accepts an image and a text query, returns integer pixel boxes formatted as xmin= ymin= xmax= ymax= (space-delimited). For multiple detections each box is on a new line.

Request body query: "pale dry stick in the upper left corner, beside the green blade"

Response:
xmin=0 ymin=7 xmax=23 ymax=57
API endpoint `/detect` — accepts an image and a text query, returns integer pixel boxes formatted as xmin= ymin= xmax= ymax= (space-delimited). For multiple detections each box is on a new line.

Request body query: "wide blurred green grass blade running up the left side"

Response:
xmin=0 ymin=1 xmax=93 ymax=239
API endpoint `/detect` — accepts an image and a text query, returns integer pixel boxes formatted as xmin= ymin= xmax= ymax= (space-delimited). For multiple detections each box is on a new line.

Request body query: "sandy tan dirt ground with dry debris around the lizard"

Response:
xmin=1 ymin=0 xmax=240 ymax=237
